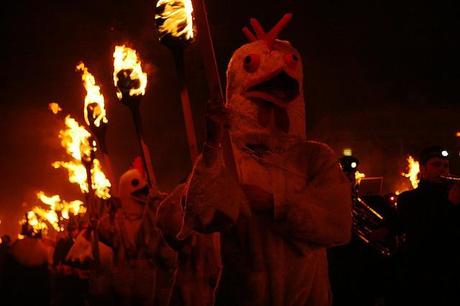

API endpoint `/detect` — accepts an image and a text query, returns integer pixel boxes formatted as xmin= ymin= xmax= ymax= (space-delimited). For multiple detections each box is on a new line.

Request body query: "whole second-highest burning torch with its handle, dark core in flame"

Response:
xmin=113 ymin=45 xmax=157 ymax=187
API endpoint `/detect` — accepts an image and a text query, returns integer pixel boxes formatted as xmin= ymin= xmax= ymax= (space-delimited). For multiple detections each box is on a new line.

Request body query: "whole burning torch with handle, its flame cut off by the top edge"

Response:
xmin=155 ymin=0 xmax=198 ymax=164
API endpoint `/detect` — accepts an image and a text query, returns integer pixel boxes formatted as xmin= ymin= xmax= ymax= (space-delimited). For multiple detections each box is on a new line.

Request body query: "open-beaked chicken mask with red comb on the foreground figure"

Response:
xmin=226 ymin=14 xmax=305 ymax=151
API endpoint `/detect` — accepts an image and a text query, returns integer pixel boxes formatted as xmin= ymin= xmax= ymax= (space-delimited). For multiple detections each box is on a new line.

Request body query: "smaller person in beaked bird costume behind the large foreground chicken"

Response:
xmin=99 ymin=167 xmax=175 ymax=305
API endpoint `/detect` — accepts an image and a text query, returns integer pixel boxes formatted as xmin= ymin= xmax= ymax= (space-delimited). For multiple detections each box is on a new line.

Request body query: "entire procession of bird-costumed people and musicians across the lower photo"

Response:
xmin=0 ymin=16 xmax=460 ymax=306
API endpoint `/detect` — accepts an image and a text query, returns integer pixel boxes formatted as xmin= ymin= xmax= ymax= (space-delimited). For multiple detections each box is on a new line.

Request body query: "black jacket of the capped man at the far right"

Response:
xmin=398 ymin=180 xmax=460 ymax=305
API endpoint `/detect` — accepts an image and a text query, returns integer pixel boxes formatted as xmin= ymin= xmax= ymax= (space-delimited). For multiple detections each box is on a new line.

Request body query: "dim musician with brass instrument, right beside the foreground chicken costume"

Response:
xmin=328 ymin=156 xmax=394 ymax=306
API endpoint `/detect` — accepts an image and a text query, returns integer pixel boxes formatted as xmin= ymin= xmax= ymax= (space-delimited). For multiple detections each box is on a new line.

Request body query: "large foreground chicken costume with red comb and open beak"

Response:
xmin=183 ymin=15 xmax=351 ymax=306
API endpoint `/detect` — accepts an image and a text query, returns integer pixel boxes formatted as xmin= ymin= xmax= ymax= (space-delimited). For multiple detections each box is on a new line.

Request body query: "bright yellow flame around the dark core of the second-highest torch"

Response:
xmin=113 ymin=45 xmax=147 ymax=99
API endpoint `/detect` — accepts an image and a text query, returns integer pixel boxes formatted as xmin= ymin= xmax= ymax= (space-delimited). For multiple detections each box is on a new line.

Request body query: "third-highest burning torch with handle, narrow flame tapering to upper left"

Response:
xmin=76 ymin=62 xmax=117 ymax=193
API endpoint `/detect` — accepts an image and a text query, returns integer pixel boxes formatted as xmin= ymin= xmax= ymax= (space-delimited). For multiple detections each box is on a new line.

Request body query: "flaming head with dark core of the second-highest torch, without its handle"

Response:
xmin=113 ymin=45 xmax=147 ymax=103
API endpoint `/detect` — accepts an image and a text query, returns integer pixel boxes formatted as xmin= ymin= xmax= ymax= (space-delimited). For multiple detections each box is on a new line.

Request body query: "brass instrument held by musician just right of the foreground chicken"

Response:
xmin=352 ymin=196 xmax=399 ymax=257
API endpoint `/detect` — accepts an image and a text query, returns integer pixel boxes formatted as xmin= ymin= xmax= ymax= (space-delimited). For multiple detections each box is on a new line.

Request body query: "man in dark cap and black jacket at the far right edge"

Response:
xmin=398 ymin=146 xmax=460 ymax=305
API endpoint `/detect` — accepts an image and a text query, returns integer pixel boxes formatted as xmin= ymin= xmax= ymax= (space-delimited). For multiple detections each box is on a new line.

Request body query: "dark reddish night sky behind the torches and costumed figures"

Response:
xmin=0 ymin=0 xmax=460 ymax=233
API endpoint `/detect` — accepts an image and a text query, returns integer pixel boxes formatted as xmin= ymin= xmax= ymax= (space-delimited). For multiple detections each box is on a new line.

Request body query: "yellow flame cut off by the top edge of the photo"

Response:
xmin=155 ymin=0 xmax=193 ymax=40
